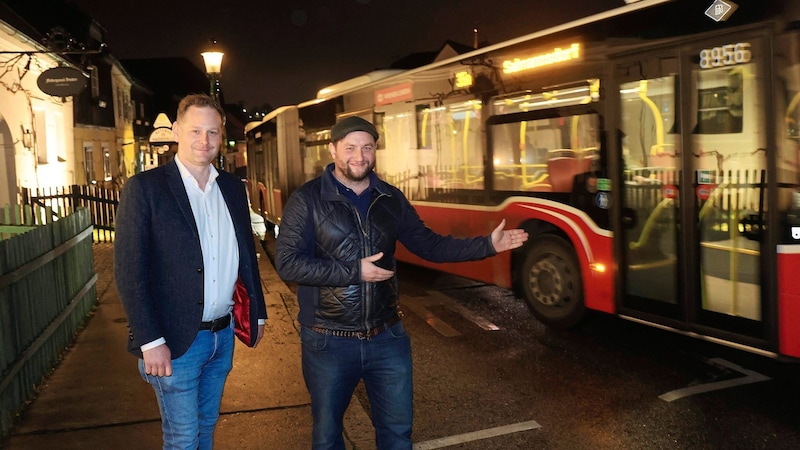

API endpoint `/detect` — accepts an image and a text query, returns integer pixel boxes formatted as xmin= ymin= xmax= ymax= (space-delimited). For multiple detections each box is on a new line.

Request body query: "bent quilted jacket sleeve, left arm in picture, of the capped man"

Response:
xmin=275 ymin=184 xmax=361 ymax=286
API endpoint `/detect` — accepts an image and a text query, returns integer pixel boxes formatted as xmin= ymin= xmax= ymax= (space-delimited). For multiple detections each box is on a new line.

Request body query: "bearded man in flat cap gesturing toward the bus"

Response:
xmin=275 ymin=116 xmax=528 ymax=450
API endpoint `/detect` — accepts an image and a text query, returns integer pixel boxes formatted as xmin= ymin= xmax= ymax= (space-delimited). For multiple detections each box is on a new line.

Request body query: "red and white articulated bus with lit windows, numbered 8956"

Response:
xmin=247 ymin=0 xmax=800 ymax=360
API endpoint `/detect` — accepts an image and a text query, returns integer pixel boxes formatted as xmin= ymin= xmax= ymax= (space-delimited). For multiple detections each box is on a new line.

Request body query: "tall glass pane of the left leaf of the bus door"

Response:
xmin=619 ymin=74 xmax=680 ymax=307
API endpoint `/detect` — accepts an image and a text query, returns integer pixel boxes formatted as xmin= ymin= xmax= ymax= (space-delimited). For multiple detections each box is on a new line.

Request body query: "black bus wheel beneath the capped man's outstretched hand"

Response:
xmin=521 ymin=235 xmax=586 ymax=329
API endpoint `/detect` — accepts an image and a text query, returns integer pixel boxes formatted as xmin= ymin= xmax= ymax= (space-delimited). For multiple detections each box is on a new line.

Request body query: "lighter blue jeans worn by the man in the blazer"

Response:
xmin=139 ymin=321 xmax=234 ymax=450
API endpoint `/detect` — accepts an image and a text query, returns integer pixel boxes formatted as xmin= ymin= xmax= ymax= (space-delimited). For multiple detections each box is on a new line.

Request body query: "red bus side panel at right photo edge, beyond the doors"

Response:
xmin=778 ymin=245 xmax=800 ymax=357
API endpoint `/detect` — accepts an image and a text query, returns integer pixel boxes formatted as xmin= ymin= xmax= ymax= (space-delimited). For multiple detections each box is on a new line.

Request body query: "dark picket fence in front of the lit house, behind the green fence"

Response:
xmin=21 ymin=185 xmax=119 ymax=242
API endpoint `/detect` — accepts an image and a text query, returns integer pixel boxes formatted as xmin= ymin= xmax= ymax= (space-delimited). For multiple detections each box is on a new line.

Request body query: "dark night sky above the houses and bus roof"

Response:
xmin=68 ymin=0 xmax=625 ymax=108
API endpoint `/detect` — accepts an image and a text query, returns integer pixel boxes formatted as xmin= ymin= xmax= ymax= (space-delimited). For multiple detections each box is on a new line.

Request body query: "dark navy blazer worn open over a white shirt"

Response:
xmin=114 ymin=159 xmax=267 ymax=359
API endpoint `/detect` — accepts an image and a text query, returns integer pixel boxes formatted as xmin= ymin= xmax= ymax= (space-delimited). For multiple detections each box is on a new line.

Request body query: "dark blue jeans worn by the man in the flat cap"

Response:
xmin=300 ymin=321 xmax=413 ymax=450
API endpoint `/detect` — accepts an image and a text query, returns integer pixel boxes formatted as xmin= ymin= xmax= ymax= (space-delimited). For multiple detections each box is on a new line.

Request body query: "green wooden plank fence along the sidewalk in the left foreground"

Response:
xmin=0 ymin=208 xmax=97 ymax=436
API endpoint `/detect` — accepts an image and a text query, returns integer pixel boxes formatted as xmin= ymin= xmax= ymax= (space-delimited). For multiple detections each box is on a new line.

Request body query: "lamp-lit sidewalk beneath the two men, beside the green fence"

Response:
xmin=0 ymin=243 xmax=374 ymax=450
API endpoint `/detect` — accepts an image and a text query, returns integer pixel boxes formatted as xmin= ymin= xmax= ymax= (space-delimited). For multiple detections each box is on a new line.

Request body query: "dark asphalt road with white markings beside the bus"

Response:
xmin=380 ymin=265 xmax=800 ymax=450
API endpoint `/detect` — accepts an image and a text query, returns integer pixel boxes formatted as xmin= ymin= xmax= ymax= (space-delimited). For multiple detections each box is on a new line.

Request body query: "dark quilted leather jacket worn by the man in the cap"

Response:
xmin=275 ymin=164 xmax=495 ymax=332
